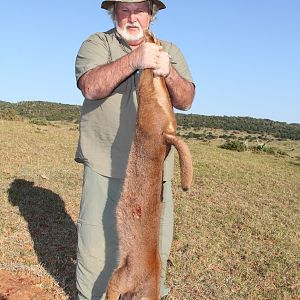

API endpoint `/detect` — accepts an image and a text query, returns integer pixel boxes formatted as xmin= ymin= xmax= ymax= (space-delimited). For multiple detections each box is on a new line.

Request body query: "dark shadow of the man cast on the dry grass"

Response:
xmin=7 ymin=179 xmax=77 ymax=299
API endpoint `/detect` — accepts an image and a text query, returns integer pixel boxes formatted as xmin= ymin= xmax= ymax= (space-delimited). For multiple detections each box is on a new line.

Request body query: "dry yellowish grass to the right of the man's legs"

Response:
xmin=169 ymin=142 xmax=300 ymax=300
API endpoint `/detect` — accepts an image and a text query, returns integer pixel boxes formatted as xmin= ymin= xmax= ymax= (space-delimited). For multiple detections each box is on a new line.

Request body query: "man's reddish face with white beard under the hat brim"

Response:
xmin=116 ymin=1 xmax=151 ymax=42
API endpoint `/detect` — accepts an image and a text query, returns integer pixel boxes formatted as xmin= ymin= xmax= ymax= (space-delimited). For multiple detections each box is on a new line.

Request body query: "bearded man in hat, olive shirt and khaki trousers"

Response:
xmin=75 ymin=0 xmax=195 ymax=300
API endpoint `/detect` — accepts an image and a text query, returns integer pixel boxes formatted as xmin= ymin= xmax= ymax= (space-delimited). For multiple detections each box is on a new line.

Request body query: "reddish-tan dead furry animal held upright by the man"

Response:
xmin=106 ymin=31 xmax=192 ymax=300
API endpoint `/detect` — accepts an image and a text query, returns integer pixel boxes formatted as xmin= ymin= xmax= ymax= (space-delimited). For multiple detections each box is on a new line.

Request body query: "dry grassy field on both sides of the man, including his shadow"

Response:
xmin=0 ymin=120 xmax=300 ymax=300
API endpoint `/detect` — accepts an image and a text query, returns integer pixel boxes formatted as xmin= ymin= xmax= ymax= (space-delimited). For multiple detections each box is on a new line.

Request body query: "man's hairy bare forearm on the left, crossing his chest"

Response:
xmin=78 ymin=52 xmax=136 ymax=100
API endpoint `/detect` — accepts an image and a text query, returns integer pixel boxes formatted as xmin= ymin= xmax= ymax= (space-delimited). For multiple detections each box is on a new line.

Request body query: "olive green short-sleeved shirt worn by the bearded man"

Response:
xmin=75 ymin=29 xmax=192 ymax=180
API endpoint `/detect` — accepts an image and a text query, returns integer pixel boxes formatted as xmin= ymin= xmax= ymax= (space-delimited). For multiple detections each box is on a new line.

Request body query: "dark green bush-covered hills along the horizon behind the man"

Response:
xmin=0 ymin=101 xmax=300 ymax=140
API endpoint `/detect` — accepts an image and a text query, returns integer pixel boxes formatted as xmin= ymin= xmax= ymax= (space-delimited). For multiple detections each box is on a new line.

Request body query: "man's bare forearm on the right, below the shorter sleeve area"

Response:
xmin=166 ymin=66 xmax=195 ymax=110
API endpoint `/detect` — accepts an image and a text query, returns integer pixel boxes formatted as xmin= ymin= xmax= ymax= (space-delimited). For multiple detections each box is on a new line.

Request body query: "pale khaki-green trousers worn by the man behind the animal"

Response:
xmin=76 ymin=166 xmax=173 ymax=300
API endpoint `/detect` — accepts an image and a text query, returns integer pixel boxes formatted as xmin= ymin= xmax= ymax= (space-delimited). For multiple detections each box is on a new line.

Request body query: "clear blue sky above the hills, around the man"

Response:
xmin=0 ymin=0 xmax=300 ymax=123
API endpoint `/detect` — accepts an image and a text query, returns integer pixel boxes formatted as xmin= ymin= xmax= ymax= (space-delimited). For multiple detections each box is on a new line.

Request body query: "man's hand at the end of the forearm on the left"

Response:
xmin=131 ymin=43 xmax=162 ymax=70
